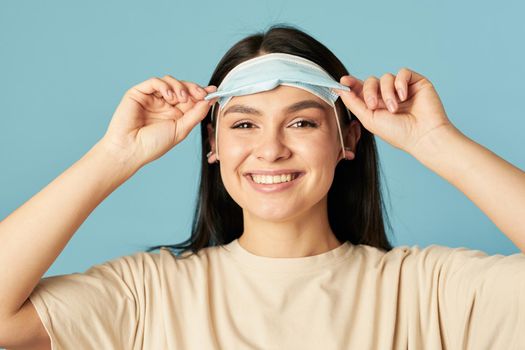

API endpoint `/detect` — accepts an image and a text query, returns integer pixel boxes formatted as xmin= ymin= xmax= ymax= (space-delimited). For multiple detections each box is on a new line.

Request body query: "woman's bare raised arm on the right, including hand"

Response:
xmin=335 ymin=68 xmax=525 ymax=252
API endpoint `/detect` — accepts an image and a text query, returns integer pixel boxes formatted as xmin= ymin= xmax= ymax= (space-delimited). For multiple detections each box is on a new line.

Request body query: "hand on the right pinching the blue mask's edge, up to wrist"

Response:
xmin=333 ymin=68 xmax=455 ymax=154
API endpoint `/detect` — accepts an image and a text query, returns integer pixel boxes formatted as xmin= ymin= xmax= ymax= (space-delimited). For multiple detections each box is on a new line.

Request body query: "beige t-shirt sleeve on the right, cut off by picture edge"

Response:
xmin=422 ymin=246 xmax=525 ymax=349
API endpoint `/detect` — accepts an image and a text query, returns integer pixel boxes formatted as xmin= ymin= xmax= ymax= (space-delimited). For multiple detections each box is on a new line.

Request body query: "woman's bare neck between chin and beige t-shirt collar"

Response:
xmin=239 ymin=197 xmax=341 ymax=258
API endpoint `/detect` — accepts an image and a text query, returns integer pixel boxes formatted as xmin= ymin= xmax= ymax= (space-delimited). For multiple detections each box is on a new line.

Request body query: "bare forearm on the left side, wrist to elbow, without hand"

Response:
xmin=0 ymin=142 xmax=136 ymax=316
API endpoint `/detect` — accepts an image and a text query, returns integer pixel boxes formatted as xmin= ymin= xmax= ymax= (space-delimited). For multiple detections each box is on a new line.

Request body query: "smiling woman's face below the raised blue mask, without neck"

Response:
xmin=210 ymin=85 xmax=342 ymax=221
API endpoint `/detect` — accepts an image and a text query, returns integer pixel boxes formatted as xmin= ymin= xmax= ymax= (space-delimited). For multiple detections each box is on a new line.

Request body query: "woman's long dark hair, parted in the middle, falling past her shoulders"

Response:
xmin=147 ymin=24 xmax=392 ymax=256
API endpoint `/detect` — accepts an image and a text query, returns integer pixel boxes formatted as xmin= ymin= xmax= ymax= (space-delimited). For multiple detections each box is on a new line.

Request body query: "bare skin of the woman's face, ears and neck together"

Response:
xmin=208 ymin=86 xmax=360 ymax=257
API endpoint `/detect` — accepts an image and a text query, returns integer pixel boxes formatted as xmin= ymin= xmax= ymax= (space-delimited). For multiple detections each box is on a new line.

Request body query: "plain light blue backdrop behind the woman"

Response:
xmin=0 ymin=0 xmax=525 ymax=276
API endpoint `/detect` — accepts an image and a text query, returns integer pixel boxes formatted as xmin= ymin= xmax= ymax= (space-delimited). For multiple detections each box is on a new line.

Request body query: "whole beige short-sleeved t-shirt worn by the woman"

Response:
xmin=30 ymin=240 xmax=525 ymax=350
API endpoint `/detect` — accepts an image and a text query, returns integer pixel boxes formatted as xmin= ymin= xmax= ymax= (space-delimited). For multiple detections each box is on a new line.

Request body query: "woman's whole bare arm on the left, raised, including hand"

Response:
xmin=0 ymin=76 xmax=217 ymax=348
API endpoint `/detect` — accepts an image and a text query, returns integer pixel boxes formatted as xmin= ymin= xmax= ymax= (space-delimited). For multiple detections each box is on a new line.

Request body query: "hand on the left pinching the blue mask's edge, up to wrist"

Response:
xmin=101 ymin=75 xmax=217 ymax=168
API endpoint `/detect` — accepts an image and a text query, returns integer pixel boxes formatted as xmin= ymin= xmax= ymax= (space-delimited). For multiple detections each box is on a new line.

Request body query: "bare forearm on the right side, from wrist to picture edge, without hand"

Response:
xmin=410 ymin=127 xmax=525 ymax=252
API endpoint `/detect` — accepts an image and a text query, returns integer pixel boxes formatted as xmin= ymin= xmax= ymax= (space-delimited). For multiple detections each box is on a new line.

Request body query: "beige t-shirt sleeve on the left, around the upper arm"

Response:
xmin=29 ymin=253 xmax=159 ymax=350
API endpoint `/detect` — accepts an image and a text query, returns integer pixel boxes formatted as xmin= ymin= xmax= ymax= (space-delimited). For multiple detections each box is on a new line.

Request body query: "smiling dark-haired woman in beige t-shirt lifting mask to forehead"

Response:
xmin=0 ymin=26 xmax=525 ymax=349
